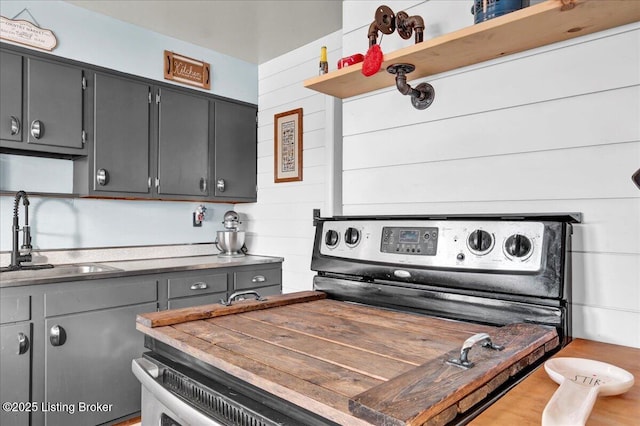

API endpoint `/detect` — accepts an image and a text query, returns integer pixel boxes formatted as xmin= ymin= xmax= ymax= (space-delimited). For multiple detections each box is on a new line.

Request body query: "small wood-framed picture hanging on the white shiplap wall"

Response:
xmin=273 ymin=108 xmax=302 ymax=183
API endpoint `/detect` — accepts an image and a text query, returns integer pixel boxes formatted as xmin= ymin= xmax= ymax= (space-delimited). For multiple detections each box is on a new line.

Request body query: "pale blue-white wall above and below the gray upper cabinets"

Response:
xmin=0 ymin=1 xmax=258 ymax=251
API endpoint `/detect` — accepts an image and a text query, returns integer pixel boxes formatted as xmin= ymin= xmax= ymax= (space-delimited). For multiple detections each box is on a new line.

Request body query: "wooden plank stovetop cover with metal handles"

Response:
xmin=137 ymin=291 xmax=558 ymax=425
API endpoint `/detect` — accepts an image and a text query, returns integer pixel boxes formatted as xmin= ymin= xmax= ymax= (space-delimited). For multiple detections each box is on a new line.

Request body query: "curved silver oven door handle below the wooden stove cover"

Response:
xmin=131 ymin=358 xmax=224 ymax=426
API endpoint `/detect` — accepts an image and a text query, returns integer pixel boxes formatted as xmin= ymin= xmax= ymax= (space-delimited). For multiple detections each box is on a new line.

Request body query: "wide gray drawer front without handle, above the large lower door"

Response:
xmin=44 ymin=279 xmax=158 ymax=317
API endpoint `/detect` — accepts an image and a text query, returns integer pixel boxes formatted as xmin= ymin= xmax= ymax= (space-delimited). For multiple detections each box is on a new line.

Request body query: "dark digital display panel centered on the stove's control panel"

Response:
xmin=380 ymin=226 xmax=438 ymax=256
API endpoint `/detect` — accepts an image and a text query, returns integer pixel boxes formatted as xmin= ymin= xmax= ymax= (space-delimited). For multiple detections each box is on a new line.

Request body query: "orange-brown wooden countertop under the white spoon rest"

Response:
xmin=471 ymin=339 xmax=640 ymax=426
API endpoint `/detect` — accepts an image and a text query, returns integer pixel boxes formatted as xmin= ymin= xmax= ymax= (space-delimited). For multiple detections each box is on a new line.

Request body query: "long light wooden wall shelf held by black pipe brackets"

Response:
xmin=304 ymin=0 xmax=640 ymax=99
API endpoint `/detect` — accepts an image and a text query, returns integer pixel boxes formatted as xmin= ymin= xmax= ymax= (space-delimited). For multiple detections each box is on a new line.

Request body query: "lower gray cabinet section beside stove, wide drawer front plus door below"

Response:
xmin=43 ymin=276 xmax=158 ymax=425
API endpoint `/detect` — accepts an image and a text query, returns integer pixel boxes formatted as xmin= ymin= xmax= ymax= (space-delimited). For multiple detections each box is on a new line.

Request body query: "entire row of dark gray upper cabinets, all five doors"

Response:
xmin=0 ymin=44 xmax=257 ymax=203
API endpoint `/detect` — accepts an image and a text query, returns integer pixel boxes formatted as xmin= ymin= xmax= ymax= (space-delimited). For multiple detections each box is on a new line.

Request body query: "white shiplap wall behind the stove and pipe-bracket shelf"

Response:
xmin=342 ymin=0 xmax=640 ymax=347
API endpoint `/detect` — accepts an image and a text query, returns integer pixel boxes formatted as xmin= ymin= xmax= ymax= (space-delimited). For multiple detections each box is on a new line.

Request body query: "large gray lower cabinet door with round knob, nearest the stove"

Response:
xmin=45 ymin=303 xmax=156 ymax=426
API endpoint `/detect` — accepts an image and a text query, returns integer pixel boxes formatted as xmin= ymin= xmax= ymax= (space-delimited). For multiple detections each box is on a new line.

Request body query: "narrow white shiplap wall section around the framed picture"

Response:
xmin=235 ymin=31 xmax=342 ymax=293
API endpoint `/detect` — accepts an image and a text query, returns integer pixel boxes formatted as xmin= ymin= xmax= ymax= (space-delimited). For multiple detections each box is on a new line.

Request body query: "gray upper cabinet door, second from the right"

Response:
xmin=158 ymin=89 xmax=209 ymax=196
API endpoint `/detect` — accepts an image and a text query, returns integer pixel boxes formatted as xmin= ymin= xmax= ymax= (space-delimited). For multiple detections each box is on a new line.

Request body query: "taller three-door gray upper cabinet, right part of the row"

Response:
xmin=74 ymin=72 xmax=257 ymax=202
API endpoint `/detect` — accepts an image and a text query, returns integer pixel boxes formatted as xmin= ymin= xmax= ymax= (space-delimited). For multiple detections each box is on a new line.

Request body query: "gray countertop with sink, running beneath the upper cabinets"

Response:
xmin=0 ymin=255 xmax=284 ymax=288
